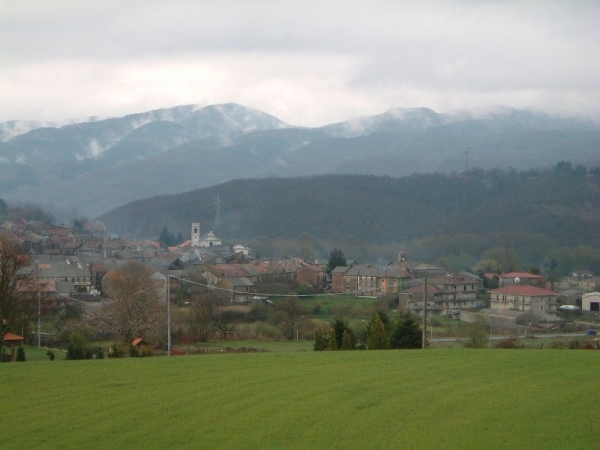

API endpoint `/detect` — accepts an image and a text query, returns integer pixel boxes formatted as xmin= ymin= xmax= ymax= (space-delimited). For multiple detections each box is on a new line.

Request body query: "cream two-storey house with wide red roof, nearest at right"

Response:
xmin=490 ymin=284 xmax=558 ymax=320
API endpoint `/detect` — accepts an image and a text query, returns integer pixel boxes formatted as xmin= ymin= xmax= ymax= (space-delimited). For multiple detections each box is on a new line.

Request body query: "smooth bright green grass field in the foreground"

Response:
xmin=0 ymin=349 xmax=600 ymax=450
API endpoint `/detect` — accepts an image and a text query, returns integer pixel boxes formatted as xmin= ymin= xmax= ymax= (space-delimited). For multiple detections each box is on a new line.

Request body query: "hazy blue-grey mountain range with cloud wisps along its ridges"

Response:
xmin=0 ymin=104 xmax=600 ymax=220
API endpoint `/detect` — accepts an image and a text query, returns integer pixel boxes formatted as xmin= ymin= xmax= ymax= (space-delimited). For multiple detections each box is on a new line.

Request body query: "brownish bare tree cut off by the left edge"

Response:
xmin=0 ymin=232 xmax=29 ymax=355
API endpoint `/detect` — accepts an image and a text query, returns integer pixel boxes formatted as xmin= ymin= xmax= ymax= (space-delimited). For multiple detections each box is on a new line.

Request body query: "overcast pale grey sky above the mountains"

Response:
xmin=0 ymin=0 xmax=600 ymax=126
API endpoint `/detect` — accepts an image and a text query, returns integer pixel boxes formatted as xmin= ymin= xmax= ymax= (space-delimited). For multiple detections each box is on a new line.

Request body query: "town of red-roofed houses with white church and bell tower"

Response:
xmin=2 ymin=220 xmax=600 ymax=356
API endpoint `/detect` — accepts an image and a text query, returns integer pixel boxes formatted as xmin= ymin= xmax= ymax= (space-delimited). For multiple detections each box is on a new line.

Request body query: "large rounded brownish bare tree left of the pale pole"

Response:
xmin=94 ymin=261 xmax=166 ymax=343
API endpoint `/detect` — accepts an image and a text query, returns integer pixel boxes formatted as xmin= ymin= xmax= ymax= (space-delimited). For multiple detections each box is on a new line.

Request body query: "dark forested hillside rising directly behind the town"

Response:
xmin=100 ymin=162 xmax=600 ymax=271
